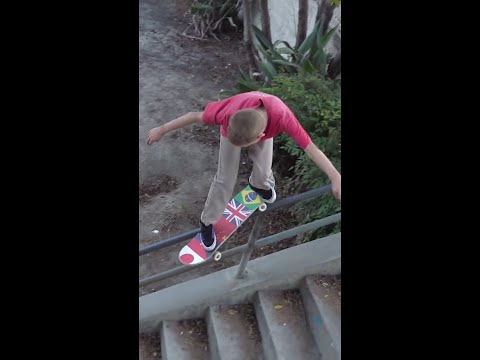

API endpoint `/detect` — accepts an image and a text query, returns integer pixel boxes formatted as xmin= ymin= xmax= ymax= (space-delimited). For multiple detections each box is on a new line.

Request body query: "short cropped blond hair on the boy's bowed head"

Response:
xmin=227 ymin=109 xmax=263 ymax=146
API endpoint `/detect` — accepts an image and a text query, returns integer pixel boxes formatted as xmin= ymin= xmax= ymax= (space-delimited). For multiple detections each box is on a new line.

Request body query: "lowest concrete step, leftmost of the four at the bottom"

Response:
xmin=161 ymin=320 xmax=209 ymax=360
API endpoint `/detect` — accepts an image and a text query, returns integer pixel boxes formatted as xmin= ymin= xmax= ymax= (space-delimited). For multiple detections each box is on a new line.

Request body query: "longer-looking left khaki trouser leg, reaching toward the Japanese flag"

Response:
xmin=200 ymin=136 xmax=241 ymax=225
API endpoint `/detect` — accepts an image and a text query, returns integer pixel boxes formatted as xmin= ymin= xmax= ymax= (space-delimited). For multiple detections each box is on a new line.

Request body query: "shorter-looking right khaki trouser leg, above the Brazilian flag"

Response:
xmin=248 ymin=138 xmax=275 ymax=202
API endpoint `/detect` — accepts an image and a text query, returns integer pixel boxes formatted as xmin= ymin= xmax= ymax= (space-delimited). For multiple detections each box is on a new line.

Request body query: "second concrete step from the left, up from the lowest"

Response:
xmin=207 ymin=304 xmax=264 ymax=360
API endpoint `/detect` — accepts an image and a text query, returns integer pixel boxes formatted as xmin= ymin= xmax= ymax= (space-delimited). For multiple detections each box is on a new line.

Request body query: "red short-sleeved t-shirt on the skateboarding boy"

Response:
xmin=203 ymin=91 xmax=311 ymax=150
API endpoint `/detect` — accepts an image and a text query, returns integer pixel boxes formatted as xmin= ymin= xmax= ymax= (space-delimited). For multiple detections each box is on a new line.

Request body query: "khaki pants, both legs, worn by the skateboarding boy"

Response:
xmin=201 ymin=136 xmax=275 ymax=225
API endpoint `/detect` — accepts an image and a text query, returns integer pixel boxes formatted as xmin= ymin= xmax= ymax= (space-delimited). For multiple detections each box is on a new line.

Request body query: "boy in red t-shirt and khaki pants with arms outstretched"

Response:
xmin=147 ymin=91 xmax=341 ymax=251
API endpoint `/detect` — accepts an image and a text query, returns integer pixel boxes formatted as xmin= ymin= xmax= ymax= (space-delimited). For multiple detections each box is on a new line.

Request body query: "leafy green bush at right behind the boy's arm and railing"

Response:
xmin=262 ymin=73 xmax=341 ymax=240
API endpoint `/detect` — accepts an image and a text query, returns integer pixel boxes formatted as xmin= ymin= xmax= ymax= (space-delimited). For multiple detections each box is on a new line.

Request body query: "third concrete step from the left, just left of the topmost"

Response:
xmin=254 ymin=290 xmax=321 ymax=360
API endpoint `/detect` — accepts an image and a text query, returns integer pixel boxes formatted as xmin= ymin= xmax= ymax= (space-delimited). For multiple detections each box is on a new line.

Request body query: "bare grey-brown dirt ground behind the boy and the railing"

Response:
xmin=139 ymin=0 xmax=342 ymax=359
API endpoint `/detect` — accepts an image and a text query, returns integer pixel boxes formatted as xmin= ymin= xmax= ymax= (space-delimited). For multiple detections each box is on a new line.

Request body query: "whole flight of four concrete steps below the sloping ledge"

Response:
xmin=160 ymin=276 xmax=341 ymax=360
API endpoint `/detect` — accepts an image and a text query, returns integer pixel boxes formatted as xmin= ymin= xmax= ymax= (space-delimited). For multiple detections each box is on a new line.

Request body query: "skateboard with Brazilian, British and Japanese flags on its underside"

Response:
xmin=178 ymin=186 xmax=267 ymax=265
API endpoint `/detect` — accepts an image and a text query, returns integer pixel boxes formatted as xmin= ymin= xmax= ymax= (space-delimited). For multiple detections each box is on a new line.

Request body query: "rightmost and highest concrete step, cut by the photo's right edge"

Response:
xmin=300 ymin=276 xmax=341 ymax=360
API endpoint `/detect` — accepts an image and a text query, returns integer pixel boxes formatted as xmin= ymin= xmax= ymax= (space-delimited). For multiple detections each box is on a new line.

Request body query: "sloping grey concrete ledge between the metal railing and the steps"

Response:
xmin=139 ymin=233 xmax=341 ymax=333
